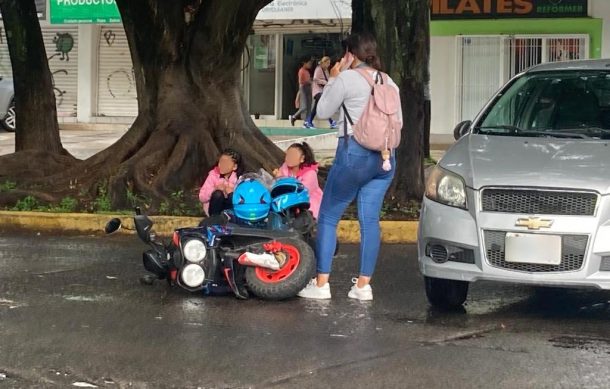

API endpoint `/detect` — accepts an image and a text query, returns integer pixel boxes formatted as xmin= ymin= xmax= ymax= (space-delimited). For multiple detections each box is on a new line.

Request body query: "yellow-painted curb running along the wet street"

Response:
xmin=0 ymin=211 xmax=418 ymax=243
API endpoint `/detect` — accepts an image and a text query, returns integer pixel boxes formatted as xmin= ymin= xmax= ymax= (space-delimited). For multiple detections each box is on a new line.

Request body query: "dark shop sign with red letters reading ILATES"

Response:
xmin=431 ymin=0 xmax=588 ymax=20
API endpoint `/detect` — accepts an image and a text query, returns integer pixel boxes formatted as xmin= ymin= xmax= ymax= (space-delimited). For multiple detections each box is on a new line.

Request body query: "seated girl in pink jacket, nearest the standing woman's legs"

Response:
xmin=274 ymin=142 xmax=322 ymax=219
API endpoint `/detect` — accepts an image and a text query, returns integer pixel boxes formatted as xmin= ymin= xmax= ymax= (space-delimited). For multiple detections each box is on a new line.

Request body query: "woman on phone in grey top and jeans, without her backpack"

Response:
xmin=299 ymin=33 xmax=402 ymax=301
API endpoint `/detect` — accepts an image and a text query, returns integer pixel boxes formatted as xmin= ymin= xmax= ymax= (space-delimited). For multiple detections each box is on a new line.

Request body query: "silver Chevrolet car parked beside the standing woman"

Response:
xmin=418 ymin=60 xmax=610 ymax=307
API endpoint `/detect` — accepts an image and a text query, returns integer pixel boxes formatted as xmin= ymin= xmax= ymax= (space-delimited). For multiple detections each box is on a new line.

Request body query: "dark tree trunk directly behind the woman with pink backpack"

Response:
xmin=352 ymin=0 xmax=430 ymax=204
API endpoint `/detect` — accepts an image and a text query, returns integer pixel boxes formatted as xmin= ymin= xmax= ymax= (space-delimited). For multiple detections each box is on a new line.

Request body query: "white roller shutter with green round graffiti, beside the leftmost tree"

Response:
xmin=42 ymin=25 xmax=78 ymax=117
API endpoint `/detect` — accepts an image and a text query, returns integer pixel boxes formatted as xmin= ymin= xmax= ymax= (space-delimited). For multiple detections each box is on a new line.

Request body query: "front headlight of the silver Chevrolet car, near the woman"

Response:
xmin=426 ymin=165 xmax=468 ymax=209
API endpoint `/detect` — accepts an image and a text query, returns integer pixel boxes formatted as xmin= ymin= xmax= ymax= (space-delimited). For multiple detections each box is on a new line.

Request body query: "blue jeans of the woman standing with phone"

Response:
xmin=316 ymin=137 xmax=396 ymax=277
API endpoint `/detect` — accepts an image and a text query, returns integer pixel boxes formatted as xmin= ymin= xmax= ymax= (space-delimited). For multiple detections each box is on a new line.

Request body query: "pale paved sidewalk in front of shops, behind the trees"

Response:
xmin=0 ymin=120 xmax=453 ymax=160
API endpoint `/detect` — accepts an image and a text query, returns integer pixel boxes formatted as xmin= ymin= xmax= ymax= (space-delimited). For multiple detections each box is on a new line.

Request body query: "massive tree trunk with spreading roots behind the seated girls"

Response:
xmin=0 ymin=0 xmax=283 ymax=208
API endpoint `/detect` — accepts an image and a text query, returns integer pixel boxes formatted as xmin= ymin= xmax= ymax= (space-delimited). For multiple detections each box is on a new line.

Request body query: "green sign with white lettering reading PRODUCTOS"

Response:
xmin=50 ymin=0 xmax=121 ymax=24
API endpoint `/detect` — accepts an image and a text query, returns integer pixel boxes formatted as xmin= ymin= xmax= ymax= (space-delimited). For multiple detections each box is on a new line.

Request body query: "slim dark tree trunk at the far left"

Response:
xmin=0 ymin=0 xmax=68 ymax=155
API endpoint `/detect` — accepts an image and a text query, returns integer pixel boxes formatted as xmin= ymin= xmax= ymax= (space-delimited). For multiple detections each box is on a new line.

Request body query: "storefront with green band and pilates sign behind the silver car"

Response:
xmin=430 ymin=0 xmax=610 ymax=134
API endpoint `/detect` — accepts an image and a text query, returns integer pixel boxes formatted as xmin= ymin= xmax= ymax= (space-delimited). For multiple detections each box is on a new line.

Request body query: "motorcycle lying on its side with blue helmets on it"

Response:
xmin=106 ymin=176 xmax=315 ymax=300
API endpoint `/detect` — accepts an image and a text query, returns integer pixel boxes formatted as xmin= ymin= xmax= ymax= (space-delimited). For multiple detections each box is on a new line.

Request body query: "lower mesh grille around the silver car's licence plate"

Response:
xmin=484 ymin=231 xmax=589 ymax=273
